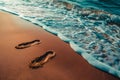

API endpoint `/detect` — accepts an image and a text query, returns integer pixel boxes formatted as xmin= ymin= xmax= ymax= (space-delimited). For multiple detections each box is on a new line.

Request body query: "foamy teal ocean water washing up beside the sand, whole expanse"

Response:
xmin=0 ymin=0 xmax=120 ymax=78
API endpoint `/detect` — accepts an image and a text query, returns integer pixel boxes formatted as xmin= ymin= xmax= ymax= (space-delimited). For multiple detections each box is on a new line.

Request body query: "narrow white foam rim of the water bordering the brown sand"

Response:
xmin=1 ymin=9 xmax=120 ymax=78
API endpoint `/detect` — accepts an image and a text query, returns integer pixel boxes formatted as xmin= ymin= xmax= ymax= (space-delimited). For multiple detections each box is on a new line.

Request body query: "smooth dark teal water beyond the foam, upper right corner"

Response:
xmin=58 ymin=0 xmax=120 ymax=15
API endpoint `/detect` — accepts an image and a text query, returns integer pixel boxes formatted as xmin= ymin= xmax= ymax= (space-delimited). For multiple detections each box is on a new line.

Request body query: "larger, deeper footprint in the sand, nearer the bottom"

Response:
xmin=29 ymin=51 xmax=56 ymax=69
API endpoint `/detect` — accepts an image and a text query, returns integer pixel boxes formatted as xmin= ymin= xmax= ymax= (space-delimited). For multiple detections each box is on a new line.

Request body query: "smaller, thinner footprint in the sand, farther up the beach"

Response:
xmin=15 ymin=40 xmax=40 ymax=49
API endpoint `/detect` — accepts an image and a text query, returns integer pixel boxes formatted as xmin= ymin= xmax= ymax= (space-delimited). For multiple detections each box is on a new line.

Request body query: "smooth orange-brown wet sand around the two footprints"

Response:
xmin=0 ymin=12 xmax=119 ymax=80
